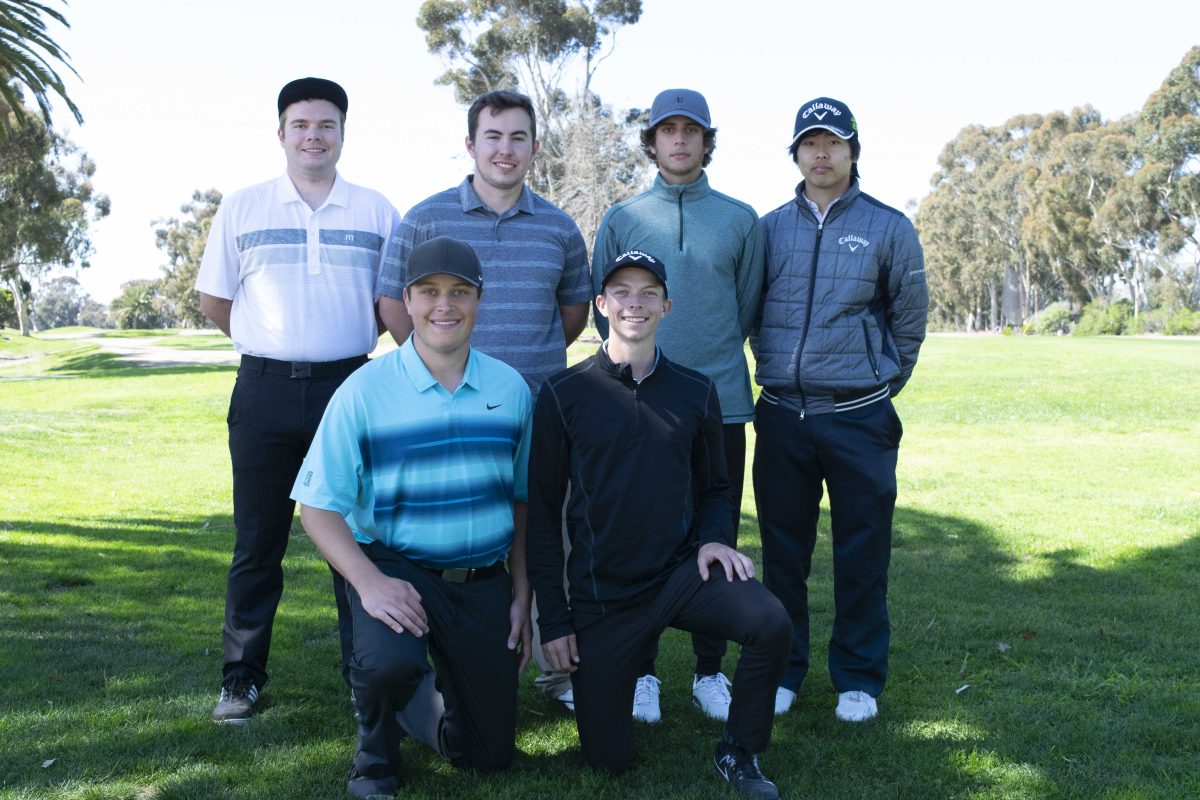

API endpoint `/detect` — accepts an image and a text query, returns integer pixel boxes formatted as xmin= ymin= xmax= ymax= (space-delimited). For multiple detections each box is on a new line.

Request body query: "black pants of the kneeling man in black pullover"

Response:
xmin=572 ymin=559 xmax=792 ymax=772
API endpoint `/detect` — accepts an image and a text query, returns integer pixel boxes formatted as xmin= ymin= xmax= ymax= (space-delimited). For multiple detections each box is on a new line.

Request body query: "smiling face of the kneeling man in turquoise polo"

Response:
xmin=404 ymin=272 xmax=480 ymax=357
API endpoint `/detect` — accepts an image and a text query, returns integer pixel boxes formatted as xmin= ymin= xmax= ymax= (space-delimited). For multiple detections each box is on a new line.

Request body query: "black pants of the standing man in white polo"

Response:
xmin=223 ymin=356 xmax=366 ymax=688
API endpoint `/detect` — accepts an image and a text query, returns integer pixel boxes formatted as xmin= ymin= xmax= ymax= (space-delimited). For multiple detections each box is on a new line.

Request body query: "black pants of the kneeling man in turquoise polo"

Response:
xmin=344 ymin=543 xmax=518 ymax=778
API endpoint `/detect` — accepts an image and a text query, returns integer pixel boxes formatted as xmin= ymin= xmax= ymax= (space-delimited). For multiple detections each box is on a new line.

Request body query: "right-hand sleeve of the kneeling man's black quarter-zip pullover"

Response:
xmin=691 ymin=381 xmax=734 ymax=547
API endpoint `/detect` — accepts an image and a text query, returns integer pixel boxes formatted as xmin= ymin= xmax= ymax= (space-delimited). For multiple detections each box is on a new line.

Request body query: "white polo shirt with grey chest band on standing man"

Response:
xmin=196 ymin=174 xmax=400 ymax=361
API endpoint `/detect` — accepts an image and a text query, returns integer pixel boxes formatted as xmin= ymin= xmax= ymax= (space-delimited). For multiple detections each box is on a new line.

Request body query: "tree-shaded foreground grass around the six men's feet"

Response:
xmin=0 ymin=509 xmax=1200 ymax=800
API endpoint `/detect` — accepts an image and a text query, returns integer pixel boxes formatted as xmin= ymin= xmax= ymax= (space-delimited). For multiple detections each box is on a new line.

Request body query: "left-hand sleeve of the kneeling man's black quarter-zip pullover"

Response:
xmin=526 ymin=383 xmax=572 ymax=642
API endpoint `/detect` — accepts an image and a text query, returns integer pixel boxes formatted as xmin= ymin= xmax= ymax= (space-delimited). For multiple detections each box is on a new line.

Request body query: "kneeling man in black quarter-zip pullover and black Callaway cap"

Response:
xmin=527 ymin=251 xmax=791 ymax=798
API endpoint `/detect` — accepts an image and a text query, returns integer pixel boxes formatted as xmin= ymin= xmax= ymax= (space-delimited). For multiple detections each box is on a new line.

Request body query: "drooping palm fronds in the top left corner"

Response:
xmin=0 ymin=0 xmax=83 ymax=139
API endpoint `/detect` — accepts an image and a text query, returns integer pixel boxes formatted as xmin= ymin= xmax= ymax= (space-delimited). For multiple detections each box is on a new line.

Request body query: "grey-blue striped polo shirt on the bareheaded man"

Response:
xmin=379 ymin=175 xmax=592 ymax=395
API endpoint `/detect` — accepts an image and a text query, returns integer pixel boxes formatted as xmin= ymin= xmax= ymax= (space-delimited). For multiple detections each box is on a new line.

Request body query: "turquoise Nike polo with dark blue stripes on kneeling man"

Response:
xmin=292 ymin=337 xmax=533 ymax=569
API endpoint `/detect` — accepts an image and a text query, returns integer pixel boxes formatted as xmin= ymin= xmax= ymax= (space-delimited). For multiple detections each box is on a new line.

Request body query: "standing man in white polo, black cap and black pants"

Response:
xmin=196 ymin=78 xmax=400 ymax=722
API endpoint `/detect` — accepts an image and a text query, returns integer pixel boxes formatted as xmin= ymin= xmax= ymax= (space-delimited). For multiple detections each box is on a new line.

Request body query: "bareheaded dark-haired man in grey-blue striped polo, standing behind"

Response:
xmin=379 ymin=90 xmax=592 ymax=396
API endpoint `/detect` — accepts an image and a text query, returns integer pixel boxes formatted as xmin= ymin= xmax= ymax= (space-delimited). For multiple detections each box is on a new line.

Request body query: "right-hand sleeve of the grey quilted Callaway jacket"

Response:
xmin=887 ymin=217 xmax=929 ymax=397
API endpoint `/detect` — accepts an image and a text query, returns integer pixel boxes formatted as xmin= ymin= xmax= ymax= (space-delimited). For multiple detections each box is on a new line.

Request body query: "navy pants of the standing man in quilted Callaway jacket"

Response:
xmin=754 ymin=399 xmax=902 ymax=697
